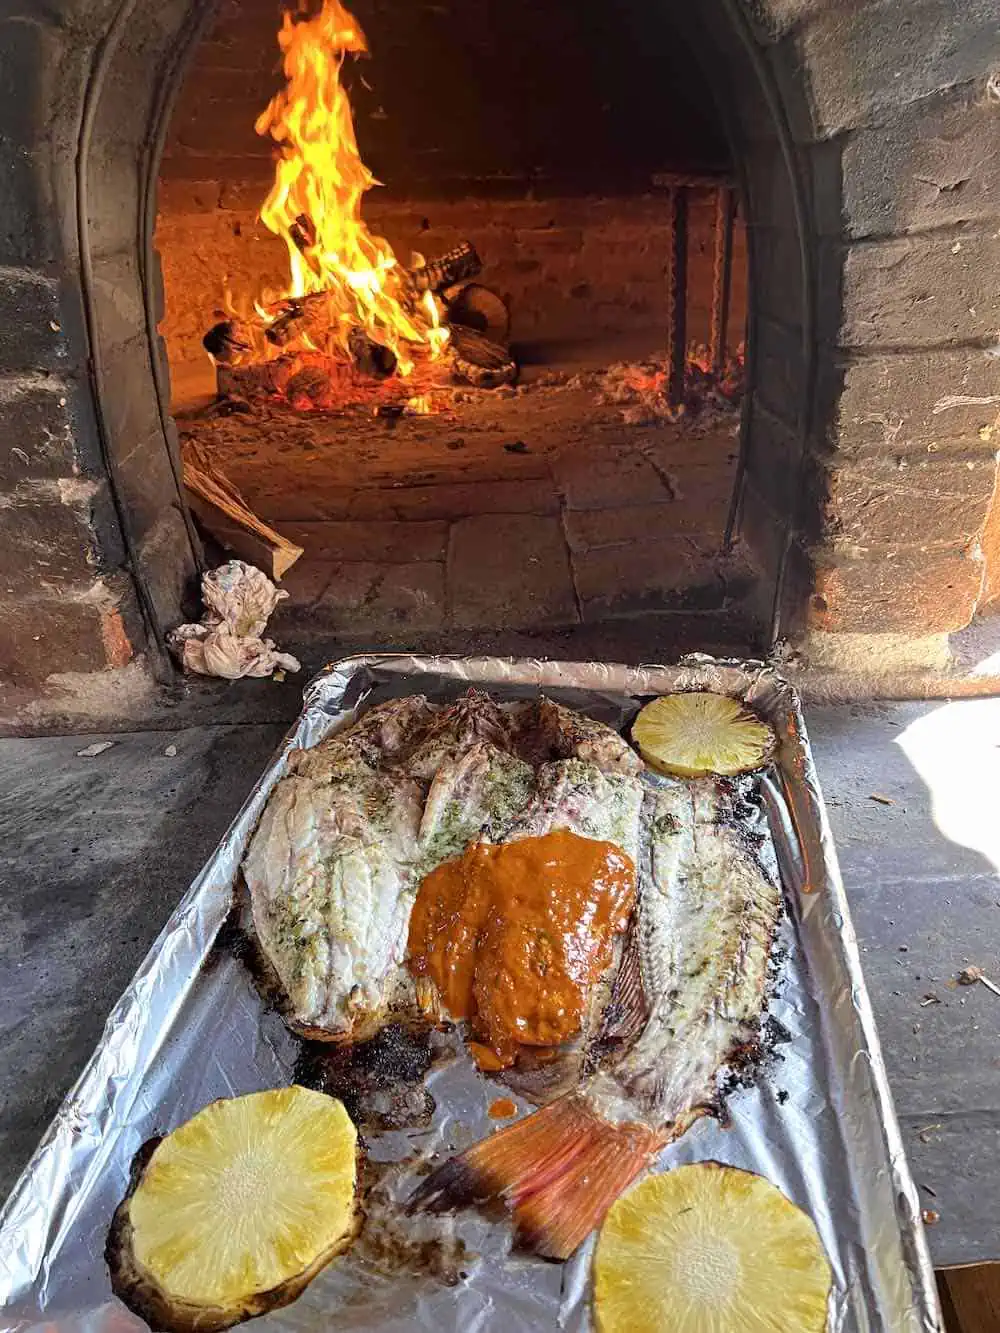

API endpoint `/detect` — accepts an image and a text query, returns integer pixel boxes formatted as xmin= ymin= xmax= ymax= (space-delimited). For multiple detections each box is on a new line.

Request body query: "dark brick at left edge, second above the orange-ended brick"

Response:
xmin=0 ymin=375 xmax=100 ymax=488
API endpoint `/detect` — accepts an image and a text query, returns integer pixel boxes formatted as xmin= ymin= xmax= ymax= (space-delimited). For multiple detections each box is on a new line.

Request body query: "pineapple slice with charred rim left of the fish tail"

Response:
xmin=107 ymin=1086 xmax=357 ymax=1330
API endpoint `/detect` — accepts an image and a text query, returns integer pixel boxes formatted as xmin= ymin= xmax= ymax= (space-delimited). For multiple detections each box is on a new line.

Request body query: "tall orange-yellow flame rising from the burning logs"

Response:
xmin=255 ymin=0 xmax=448 ymax=375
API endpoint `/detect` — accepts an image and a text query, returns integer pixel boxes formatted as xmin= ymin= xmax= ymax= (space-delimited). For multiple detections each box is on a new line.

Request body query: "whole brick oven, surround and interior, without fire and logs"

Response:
xmin=0 ymin=0 xmax=1000 ymax=720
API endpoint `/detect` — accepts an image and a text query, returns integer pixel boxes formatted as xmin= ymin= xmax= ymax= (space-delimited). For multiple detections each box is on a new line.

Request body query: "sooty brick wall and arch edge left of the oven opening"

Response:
xmin=0 ymin=4 xmax=201 ymax=709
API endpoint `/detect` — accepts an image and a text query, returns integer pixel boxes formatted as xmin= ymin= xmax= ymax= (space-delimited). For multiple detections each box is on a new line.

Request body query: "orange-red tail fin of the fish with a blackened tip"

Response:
xmin=408 ymin=1094 xmax=664 ymax=1260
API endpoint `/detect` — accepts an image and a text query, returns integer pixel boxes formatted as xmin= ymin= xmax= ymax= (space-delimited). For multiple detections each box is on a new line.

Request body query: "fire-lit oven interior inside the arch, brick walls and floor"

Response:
xmin=155 ymin=0 xmax=756 ymax=649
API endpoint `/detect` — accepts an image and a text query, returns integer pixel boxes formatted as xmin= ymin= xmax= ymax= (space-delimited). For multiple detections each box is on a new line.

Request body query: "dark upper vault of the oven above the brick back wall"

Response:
xmin=163 ymin=0 xmax=729 ymax=199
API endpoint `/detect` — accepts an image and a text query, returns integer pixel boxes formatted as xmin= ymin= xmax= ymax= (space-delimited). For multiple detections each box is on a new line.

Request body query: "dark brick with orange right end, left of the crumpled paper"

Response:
xmin=0 ymin=585 xmax=135 ymax=689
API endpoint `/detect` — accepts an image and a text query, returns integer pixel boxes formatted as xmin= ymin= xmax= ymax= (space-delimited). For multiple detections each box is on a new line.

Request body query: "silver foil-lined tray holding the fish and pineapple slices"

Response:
xmin=0 ymin=656 xmax=943 ymax=1333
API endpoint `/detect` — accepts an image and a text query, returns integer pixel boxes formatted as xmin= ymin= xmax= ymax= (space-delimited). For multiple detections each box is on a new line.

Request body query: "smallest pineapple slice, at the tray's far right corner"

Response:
xmin=632 ymin=693 xmax=777 ymax=777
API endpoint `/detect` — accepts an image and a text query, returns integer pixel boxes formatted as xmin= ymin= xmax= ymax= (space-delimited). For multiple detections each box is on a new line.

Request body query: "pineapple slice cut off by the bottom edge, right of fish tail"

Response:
xmin=593 ymin=1162 xmax=831 ymax=1333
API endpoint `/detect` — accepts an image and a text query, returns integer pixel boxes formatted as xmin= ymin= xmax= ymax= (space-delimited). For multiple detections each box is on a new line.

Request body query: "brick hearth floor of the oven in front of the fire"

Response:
xmin=179 ymin=368 xmax=755 ymax=645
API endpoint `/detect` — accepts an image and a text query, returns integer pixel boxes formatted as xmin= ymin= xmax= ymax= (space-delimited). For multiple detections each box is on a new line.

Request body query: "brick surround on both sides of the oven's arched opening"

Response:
xmin=0 ymin=0 xmax=1000 ymax=709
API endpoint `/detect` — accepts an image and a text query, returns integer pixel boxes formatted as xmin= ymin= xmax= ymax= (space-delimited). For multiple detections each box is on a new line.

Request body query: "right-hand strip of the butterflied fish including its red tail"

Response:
xmin=412 ymin=780 xmax=781 ymax=1258
